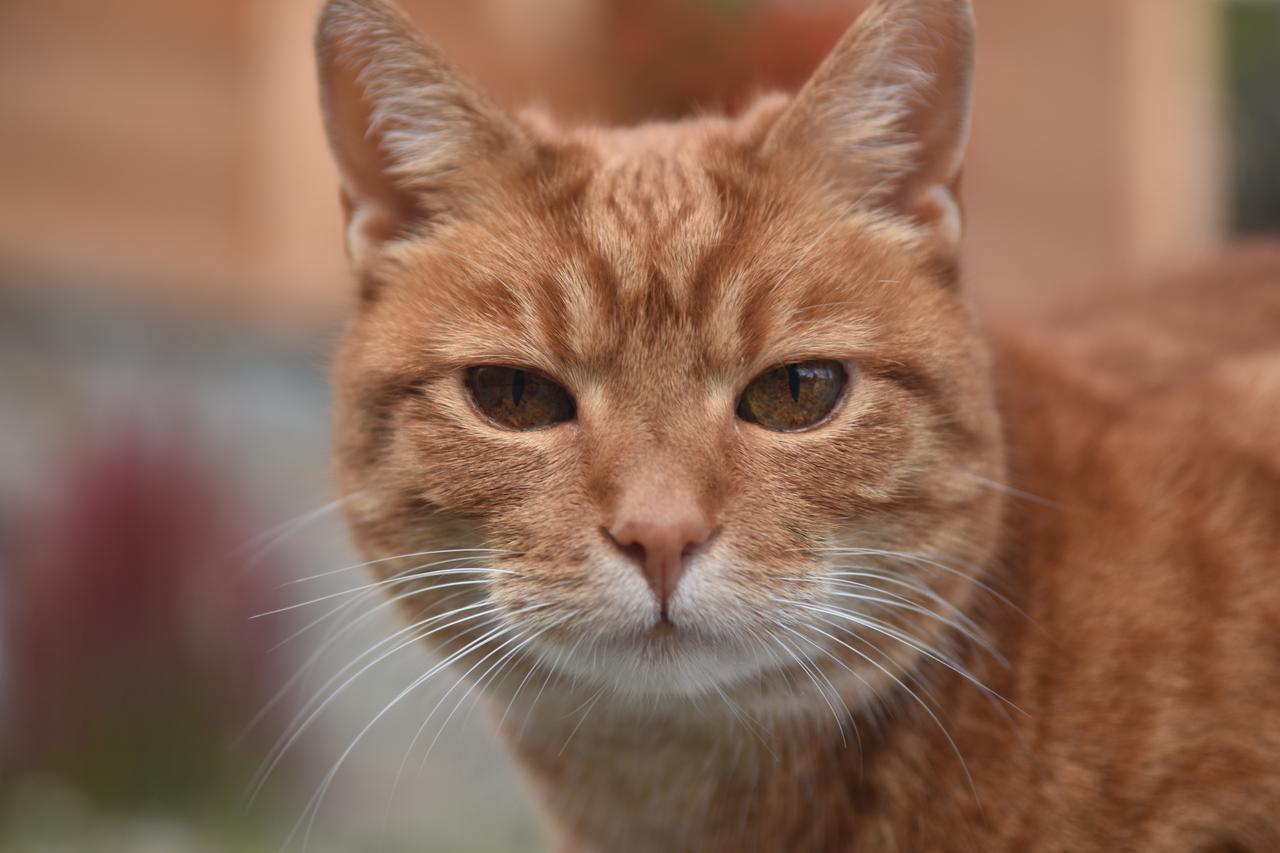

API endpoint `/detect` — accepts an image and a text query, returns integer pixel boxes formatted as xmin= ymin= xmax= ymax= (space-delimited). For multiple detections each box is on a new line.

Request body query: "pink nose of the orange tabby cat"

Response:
xmin=605 ymin=500 xmax=713 ymax=620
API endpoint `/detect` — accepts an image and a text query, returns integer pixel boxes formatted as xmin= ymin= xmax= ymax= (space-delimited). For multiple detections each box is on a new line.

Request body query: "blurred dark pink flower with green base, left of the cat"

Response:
xmin=0 ymin=429 xmax=300 ymax=802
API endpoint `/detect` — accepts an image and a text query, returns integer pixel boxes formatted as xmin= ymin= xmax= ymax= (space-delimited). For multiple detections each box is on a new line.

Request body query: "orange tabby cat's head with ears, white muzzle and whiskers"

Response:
xmin=317 ymin=0 xmax=1002 ymax=706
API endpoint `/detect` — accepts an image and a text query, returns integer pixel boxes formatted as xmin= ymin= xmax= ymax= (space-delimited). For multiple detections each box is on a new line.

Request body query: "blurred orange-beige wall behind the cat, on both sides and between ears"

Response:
xmin=0 ymin=0 xmax=1224 ymax=328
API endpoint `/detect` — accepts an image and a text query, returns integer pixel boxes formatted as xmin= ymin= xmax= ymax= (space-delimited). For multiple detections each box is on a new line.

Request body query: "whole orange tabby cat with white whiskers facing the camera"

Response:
xmin=317 ymin=0 xmax=1280 ymax=853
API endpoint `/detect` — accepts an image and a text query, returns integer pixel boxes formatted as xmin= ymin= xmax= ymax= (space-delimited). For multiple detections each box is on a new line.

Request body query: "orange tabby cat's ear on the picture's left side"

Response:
xmin=316 ymin=0 xmax=530 ymax=269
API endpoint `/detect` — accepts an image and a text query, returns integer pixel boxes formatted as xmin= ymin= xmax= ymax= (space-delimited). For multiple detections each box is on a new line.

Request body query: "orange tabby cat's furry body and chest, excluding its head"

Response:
xmin=494 ymin=252 xmax=1280 ymax=852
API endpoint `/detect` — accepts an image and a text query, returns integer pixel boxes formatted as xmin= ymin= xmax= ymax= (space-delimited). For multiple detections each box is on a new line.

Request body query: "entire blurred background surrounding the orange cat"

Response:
xmin=0 ymin=0 xmax=1280 ymax=853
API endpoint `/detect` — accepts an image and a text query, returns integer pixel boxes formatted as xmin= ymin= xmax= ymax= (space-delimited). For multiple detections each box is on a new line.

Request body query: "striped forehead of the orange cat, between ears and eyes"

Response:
xmin=371 ymin=126 xmax=931 ymax=374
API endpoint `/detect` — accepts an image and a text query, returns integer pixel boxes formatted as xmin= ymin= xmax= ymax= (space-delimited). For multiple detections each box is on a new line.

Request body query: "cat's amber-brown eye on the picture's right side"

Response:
xmin=737 ymin=361 xmax=847 ymax=433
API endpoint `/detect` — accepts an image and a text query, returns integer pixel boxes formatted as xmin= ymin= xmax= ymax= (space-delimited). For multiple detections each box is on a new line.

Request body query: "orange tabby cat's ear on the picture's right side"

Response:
xmin=764 ymin=0 xmax=973 ymax=261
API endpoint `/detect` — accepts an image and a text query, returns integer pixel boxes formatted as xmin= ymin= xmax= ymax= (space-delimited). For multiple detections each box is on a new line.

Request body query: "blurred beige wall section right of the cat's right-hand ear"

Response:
xmin=965 ymin=0 xmax=1225 ymax=312
